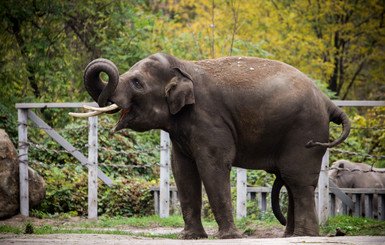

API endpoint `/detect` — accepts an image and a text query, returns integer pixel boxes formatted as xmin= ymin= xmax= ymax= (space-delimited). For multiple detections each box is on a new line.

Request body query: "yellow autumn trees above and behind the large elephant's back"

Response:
xmin=157 ymin=0 xmax=385 ymax=99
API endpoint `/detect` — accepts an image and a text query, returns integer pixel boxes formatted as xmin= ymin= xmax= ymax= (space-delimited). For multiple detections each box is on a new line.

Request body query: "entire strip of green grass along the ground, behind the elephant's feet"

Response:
xmin=0 ymin=213 xmax=385 ymax=239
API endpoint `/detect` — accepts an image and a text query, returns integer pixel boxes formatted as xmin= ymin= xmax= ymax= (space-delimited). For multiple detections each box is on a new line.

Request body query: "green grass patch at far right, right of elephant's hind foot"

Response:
xmin=321 ymin=215 xmax=385 ymax=236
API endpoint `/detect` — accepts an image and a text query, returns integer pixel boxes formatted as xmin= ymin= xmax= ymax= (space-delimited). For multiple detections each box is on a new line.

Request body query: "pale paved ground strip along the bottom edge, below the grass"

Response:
xmin=0 ymin=233 xmax=385 ymax=245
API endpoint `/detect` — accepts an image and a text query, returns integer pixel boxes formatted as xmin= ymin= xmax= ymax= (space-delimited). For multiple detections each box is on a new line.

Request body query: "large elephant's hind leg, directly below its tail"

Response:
xmin=278 ymin=128 xmax=327 ymax=236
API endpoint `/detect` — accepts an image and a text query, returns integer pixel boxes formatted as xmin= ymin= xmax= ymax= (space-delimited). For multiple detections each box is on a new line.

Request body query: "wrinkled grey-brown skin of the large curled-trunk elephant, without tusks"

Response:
xmin=84 ymin=54 xmax=350 ymax=239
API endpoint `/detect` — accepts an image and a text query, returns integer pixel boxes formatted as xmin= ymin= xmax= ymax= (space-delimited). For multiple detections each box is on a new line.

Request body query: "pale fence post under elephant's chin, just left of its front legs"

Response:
xmin=159 ymin=130 xmax=170 ymax=218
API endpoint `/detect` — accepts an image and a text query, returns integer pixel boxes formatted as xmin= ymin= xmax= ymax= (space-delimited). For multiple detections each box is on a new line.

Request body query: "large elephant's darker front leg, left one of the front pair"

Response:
xmin=172 ymin=147 xmax=207 ymax=239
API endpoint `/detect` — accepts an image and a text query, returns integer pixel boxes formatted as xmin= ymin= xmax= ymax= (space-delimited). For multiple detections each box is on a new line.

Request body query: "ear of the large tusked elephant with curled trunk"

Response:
xmin=165 ymin=68 xmax=195 ymax=115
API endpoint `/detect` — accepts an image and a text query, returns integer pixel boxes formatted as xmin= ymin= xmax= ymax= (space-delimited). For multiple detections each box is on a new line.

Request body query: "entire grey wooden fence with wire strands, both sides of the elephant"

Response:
xmin=16 ymin=101 xmax=385 ymax=222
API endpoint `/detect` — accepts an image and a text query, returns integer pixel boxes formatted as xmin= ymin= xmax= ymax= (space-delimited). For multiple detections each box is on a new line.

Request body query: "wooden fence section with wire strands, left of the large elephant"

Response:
xmin=16 ymin=103 xmax=170 ymax=219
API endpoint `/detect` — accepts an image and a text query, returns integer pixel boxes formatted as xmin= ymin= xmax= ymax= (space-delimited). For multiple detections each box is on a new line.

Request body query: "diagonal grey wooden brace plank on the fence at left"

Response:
xmin=28 ymin=110 xmax=114 ymax=187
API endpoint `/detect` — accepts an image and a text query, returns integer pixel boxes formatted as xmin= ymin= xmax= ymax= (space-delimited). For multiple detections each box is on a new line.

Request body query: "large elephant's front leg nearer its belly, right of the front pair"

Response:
xmin=199 ymin=164 xmax=242 ymax=239
